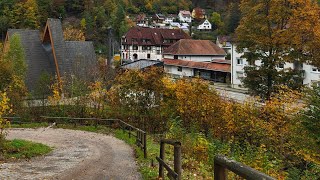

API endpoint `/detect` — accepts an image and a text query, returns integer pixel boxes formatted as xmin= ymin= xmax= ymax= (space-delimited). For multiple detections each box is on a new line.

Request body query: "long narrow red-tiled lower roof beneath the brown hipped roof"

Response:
xmin=162 ymin=59 xmax=231 ymax=73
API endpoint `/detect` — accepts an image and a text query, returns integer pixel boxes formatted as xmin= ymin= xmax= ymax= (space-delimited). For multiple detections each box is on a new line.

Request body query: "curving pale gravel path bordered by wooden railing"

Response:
xmin=0 ymin=128 xmax=141 ymax=180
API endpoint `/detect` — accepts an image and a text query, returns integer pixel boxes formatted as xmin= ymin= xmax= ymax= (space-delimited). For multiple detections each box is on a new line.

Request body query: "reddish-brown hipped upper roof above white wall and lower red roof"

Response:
xmin=163 ymin=39 xmax=226 ymax=56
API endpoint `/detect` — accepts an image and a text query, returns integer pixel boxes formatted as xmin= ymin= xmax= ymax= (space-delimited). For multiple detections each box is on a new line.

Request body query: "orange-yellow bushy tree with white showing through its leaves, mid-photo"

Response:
xmin=108 ymin=67 xmax=165 ymax=132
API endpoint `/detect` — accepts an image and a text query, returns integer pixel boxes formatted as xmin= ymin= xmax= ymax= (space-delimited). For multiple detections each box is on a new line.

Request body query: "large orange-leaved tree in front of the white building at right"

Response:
xmin=236 ymin=0 xmax=320 ymax=99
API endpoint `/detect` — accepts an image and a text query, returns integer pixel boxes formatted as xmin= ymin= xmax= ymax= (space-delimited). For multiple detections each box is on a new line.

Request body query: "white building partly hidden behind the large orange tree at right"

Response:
xmin=217 ymin=37 xmax=320 ymax=88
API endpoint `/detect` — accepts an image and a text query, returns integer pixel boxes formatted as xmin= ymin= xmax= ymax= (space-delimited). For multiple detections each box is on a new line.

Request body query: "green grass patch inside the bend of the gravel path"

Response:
xmin=4 ymin=139 xmax=52 ymax=159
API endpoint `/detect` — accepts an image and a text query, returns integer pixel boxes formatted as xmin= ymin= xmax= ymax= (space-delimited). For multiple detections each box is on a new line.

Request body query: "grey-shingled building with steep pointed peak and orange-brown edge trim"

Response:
xmin=5 ymin=19 xmax=97 ymax=91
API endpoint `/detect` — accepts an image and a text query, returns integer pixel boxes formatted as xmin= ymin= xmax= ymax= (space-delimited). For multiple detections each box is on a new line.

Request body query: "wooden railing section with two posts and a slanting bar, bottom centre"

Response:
xmin=156 ymin=139 xmax=182 ymax=180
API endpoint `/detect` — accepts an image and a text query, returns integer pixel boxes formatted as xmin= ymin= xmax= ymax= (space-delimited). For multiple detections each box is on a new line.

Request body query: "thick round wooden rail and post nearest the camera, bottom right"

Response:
xmin=214 ymin=155 xmax=274 ymax=180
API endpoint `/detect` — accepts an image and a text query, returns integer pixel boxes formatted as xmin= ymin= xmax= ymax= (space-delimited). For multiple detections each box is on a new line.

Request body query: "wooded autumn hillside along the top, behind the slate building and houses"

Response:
xmin=0 ymin=0 xmax=239 ymax=50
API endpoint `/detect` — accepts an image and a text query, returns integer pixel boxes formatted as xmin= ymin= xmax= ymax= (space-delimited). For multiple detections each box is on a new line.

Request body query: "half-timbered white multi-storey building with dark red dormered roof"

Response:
xmin=121 ymin=27 xmax=190 ymax=62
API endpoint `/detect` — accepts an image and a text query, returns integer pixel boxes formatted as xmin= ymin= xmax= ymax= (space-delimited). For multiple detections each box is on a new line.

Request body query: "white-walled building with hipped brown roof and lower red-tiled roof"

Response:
xmin=162 ymin=39 xmax=231 ymax=83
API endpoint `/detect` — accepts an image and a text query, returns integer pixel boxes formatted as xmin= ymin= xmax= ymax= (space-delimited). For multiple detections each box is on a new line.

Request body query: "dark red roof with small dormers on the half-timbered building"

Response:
xmin=122 ymin=27 xmax=190 ymax=46
